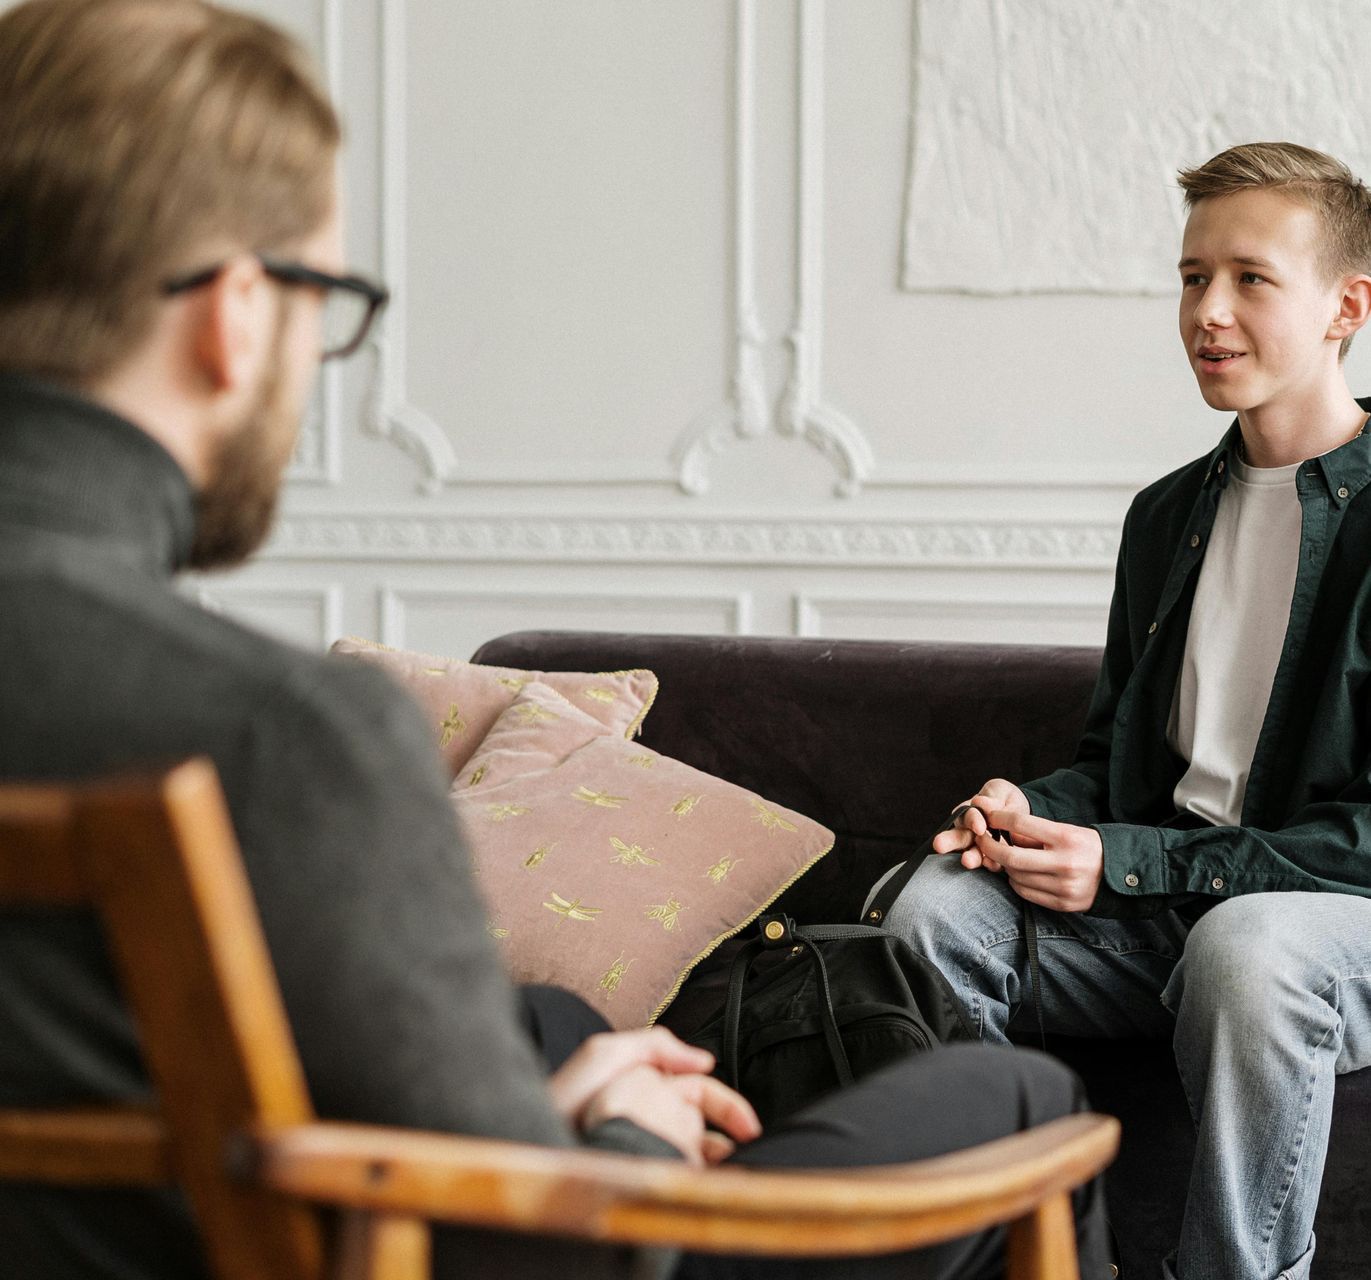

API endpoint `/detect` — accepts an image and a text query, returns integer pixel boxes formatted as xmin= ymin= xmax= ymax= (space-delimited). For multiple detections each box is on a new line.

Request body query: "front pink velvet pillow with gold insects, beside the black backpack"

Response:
xmin=452 ymin=682 xmax=834 ymax=1028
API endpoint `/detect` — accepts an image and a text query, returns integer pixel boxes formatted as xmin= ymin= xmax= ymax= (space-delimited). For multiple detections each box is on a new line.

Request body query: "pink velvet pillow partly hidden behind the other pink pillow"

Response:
xmin=329 ymin=636 xmax=657 ymax=777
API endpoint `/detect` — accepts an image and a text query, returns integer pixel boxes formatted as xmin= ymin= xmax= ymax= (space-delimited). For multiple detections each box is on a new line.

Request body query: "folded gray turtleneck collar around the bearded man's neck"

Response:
xmin=0 ymin=374 xmax=195 ymax=576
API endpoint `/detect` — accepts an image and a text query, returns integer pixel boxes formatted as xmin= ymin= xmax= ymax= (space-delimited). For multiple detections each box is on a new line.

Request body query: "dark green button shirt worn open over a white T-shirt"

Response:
xmin=1024 ymin=399 xmax=1371 ymax=915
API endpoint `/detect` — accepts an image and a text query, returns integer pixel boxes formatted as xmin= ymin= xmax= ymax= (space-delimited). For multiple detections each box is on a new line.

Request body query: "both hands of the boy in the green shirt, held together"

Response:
xmin=932 ymin=778 xmax=1105 ymax=911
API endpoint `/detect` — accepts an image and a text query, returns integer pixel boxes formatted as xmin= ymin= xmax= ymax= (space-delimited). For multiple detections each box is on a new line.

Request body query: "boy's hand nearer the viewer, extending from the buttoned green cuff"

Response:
xmin=961 ymin=809 xmax=1105 ymax=911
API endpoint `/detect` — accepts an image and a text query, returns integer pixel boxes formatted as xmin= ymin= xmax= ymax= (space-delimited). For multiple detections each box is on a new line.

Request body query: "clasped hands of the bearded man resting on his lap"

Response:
xmin=548 ymin=1026 xmax=762 ymax=1165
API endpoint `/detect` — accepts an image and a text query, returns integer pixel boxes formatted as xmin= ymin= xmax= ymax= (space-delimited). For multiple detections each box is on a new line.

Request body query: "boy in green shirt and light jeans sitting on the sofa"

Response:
xmin=887 ymin=143 xmax=1371 ymax=1280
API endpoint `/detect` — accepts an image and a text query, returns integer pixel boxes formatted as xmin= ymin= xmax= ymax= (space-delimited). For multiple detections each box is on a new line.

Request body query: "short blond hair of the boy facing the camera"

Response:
xmin=1178 ymin=143 xmax=1371 ymax=359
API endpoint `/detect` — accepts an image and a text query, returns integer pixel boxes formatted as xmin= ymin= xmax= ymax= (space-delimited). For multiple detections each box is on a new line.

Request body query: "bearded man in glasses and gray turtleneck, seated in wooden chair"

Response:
xmin=0 ymin=0 xmax=1101 ymax=1280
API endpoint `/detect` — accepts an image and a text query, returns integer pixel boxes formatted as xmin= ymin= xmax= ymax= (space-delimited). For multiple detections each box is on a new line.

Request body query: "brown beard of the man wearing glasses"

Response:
xmin=189 ymin=335 xmax=296 ymax=569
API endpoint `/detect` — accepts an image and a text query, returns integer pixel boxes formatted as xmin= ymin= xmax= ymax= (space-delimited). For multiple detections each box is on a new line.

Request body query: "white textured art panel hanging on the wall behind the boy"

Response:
xmin=902 ymin=0 xmax=1371 ymax=295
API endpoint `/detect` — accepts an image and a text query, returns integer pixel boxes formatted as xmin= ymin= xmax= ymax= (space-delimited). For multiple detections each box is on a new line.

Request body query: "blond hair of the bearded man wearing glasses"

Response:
xmin=0 ymin=0 xmax=340 ymax=384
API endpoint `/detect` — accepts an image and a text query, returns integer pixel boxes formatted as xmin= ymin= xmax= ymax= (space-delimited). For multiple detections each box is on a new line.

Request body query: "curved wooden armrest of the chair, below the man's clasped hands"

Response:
xmin=237 ymin=1114 xmax=1119 ymax=1255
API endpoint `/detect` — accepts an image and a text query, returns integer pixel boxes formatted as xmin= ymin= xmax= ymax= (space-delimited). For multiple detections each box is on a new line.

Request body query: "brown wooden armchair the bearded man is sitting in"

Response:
xmin=0 ymin=761 xmax=1119 ymax=1280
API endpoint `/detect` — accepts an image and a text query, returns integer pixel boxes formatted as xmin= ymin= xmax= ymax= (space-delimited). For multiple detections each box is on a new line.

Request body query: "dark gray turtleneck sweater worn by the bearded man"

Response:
xmin=0 ymin=376 xmax=664 ymax=1280
